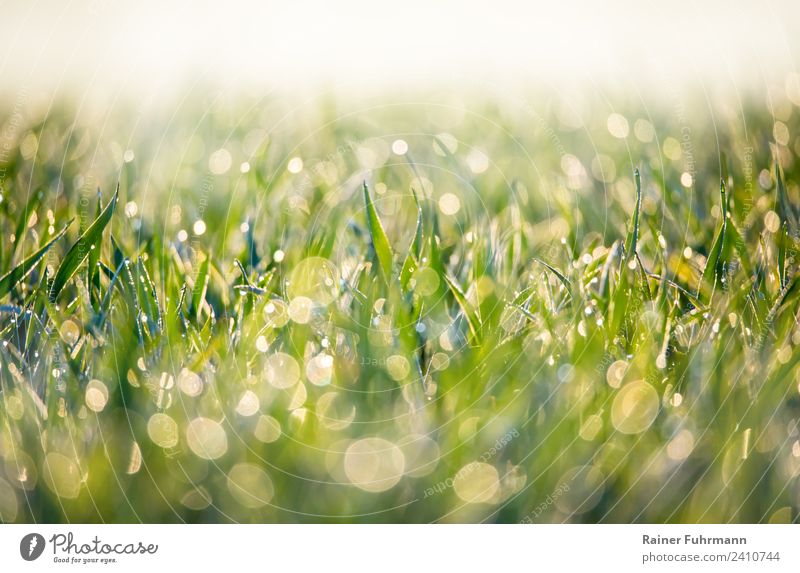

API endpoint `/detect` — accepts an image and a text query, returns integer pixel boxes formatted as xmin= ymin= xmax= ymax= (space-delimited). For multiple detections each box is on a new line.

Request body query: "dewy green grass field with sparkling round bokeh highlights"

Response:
xmin=0 ymin=90 xmax=800 ymax=523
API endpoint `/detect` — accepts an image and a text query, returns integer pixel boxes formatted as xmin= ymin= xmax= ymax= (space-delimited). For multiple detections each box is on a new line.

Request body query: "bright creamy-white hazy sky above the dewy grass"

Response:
xmin=0 ymin=0 xmax=800 ymax=98
